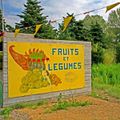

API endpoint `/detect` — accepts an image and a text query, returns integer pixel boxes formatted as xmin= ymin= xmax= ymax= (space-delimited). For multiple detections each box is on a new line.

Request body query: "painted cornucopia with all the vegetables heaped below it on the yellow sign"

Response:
xmin=9 ymin=45 xmax=62 ymax=93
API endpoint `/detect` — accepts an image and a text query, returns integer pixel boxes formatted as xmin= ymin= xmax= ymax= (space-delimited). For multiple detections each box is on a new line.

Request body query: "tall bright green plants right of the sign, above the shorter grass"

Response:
xmin=92 ymin=64 xmax=120 ymax=85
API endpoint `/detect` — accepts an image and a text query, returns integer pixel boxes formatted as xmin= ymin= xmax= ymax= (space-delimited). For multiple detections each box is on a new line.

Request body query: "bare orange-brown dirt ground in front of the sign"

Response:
xmin=8 ymin=96 xmax=120 ymax=120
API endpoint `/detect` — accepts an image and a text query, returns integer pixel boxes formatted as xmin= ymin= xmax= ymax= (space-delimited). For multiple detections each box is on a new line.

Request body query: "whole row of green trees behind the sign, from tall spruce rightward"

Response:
xmin=13 ymin=0 xmax=120 ymax=63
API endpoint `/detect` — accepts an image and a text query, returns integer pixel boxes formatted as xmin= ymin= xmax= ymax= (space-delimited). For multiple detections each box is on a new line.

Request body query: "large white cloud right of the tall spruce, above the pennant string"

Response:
xmin=44 ymin=0 xmax=117 ymax=19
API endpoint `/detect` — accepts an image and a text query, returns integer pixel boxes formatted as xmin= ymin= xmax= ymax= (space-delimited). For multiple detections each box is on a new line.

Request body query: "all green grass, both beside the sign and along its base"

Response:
xmin=0 ymin=64 xmax=120 ymax=117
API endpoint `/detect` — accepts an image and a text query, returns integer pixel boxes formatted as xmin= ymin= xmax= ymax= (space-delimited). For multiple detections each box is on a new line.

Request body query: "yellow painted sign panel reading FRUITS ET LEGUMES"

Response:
xmin=8 ymin=42 xmax=85 ymax=98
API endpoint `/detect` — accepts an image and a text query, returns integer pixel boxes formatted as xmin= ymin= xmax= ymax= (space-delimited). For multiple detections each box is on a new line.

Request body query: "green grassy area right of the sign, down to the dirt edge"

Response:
xmin=92 ymin=64 xmax=120 ymax=99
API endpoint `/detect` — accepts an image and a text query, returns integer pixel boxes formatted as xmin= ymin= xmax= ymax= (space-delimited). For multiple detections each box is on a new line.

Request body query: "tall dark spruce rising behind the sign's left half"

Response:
xmin=16 ymin=0 xmax=47 ymax=33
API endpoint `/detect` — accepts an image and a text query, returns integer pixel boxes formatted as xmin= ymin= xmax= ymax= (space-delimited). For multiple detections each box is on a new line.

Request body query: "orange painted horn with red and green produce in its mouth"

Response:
xmin=9 ymin=45 xmax=49 ymax=70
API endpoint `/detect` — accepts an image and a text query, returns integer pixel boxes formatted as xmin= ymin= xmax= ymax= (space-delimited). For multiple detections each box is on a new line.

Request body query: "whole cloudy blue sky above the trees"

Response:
xmin=0 ymin=0 xmax=120 ymax=26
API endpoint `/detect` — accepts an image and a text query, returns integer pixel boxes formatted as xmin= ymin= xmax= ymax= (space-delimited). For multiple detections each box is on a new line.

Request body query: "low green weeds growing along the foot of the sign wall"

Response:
xmin=0 ymin=94 xmax=92 ymax=118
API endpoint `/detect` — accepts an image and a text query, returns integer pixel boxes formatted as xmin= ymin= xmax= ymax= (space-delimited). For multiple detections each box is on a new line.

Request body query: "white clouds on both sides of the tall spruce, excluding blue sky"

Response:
xmin=3 ymin=0 xmax=118 ymax=25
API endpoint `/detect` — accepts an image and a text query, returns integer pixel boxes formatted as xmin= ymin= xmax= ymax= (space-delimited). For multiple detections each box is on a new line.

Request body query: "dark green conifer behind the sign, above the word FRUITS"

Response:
xmin=59 ymin=13 xmax=89 ymax=41
